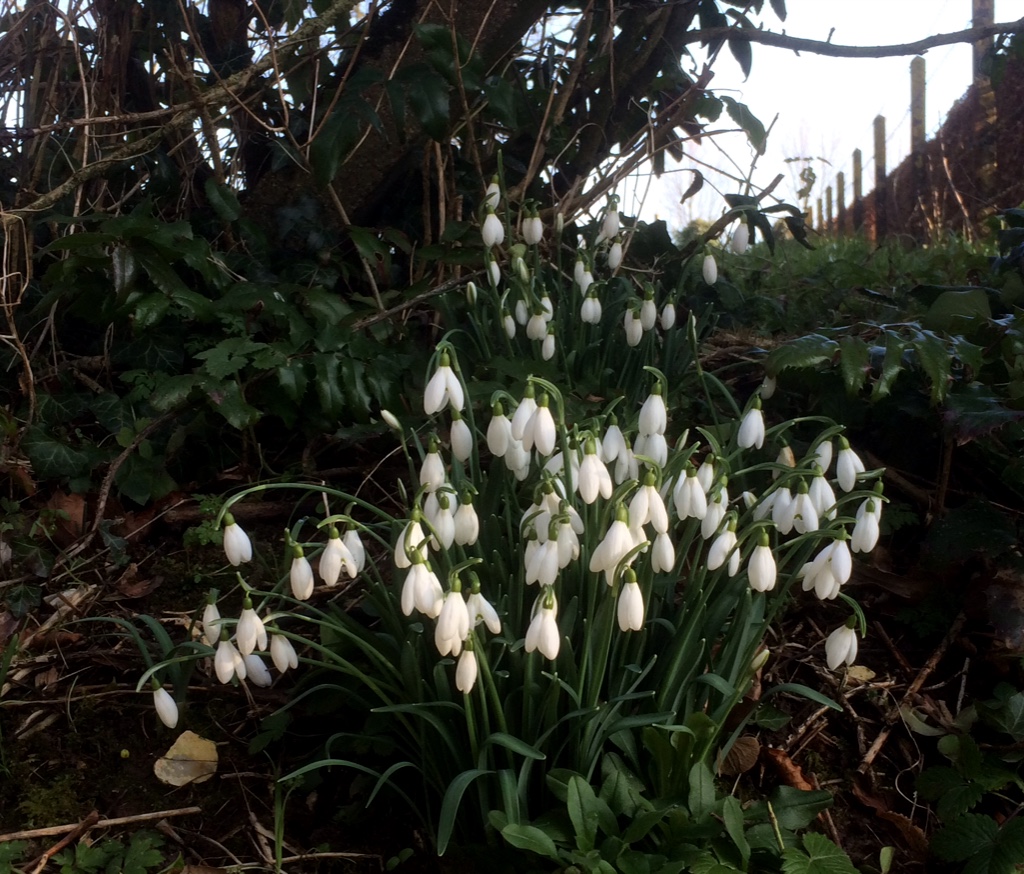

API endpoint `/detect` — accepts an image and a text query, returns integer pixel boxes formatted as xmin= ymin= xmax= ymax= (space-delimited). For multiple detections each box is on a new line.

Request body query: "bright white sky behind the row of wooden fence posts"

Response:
xmin=623 ymin=0 xmax=1024 ymax=227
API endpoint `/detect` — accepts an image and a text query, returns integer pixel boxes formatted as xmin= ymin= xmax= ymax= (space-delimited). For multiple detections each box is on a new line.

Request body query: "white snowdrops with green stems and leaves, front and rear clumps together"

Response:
xmin=140 ymin=188 xmax=883 ymax=851
